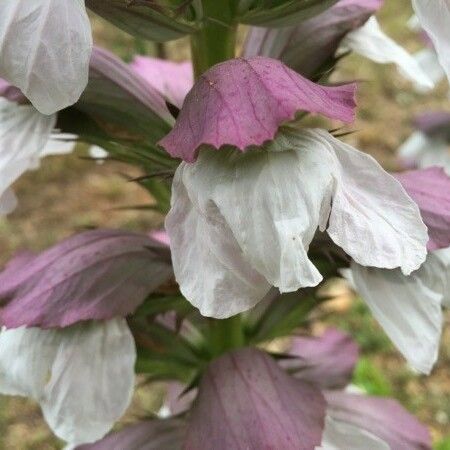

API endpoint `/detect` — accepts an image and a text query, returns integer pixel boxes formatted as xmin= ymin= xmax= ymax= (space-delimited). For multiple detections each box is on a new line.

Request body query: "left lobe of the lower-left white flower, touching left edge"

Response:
xmin=0 ymin=328 xmax=59 ymax=400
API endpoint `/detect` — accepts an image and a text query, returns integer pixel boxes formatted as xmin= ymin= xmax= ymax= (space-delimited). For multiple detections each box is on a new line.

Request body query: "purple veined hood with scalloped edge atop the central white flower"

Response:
xmin=159 ymin=57 xmax=356 ymax=162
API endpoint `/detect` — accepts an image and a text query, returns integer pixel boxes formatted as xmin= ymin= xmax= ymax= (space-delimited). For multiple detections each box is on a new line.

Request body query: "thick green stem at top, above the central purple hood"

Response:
xmin=191 ymin=0 xmax=237 ymax=78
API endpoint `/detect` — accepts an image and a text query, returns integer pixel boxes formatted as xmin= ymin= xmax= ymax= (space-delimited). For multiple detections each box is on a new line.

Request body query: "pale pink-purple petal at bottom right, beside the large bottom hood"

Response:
xmin=325 ymin=391 xmax=431 ymax=450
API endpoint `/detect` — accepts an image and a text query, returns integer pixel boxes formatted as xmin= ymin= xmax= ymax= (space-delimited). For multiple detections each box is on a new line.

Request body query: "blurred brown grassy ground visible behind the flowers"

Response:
xmin=0 ymin=0 xmax=450 ymax=450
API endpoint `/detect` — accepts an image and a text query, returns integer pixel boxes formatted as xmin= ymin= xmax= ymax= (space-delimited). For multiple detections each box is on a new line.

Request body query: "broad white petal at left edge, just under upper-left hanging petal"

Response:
xmin=0 ymin=98 xmax=56 ymax=200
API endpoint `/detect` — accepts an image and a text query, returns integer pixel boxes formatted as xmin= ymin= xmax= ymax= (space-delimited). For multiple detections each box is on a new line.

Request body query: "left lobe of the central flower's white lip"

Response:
xmin=165 ymin=167 xmax=270 ymax=318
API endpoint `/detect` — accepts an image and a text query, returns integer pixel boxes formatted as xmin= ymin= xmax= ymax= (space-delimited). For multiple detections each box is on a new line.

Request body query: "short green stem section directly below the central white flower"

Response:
xmin=209 ymin=315 xmax=245 ymax=356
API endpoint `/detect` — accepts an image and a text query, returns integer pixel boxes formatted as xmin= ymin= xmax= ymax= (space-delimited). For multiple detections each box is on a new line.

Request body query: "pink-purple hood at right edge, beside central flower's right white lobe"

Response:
xmin=395 ymin=167 xmax=450 ymax=251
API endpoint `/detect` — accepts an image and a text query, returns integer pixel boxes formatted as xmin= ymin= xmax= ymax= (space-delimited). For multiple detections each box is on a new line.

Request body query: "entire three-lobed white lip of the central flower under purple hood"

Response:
xmin=166 ymin=129 xmax=428 ymax=318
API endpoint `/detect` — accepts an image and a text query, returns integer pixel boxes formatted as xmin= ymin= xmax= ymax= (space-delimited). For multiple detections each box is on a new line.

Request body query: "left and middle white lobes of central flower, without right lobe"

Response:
xmin=166 ymin=135 xmax=333 ymax=318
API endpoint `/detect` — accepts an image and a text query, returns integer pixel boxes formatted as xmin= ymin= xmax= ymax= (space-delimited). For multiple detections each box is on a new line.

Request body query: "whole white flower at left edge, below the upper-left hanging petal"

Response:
xmin=0 ymin=98 xmax=74 ymax=215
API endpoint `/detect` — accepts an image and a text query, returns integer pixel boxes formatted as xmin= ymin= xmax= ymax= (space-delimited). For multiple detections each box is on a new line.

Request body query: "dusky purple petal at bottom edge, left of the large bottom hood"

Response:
xmin=76 ymin=419 xmax=185 ymax=450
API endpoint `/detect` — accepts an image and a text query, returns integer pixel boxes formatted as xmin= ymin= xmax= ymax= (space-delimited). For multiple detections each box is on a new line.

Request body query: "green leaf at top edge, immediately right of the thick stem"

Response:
xmin=239 ymin=0 xmax=337 ymax=28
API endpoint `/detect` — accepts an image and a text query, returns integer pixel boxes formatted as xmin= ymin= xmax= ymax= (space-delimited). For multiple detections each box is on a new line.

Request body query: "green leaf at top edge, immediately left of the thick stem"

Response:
xmin=86 ymin=0 xmax=196 ymax=42
